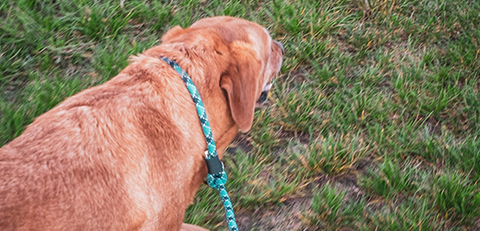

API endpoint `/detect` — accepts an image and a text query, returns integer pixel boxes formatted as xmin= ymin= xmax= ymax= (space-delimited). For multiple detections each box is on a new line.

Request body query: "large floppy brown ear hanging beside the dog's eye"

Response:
xmin=220 ymin=42 xmax=263 ymax=132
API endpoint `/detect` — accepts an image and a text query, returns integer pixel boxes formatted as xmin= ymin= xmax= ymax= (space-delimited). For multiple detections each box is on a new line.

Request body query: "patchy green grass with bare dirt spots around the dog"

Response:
xmin=0 ymin=0 xmax=480 ymax=231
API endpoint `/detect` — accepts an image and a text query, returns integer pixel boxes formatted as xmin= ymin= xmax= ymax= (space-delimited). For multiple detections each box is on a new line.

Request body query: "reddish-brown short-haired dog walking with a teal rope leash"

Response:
xmin=0 ymin=17 xmax=283 ymax=230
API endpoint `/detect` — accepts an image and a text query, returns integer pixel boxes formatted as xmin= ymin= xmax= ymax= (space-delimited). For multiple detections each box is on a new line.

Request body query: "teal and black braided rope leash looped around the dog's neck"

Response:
xmin=160 ymin=57 xmax=238 ymax=231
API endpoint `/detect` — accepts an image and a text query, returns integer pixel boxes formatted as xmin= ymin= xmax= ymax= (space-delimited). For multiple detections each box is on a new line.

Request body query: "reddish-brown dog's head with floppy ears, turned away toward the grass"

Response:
xmin=162 ymin=16 xmax=284 ymax=132
